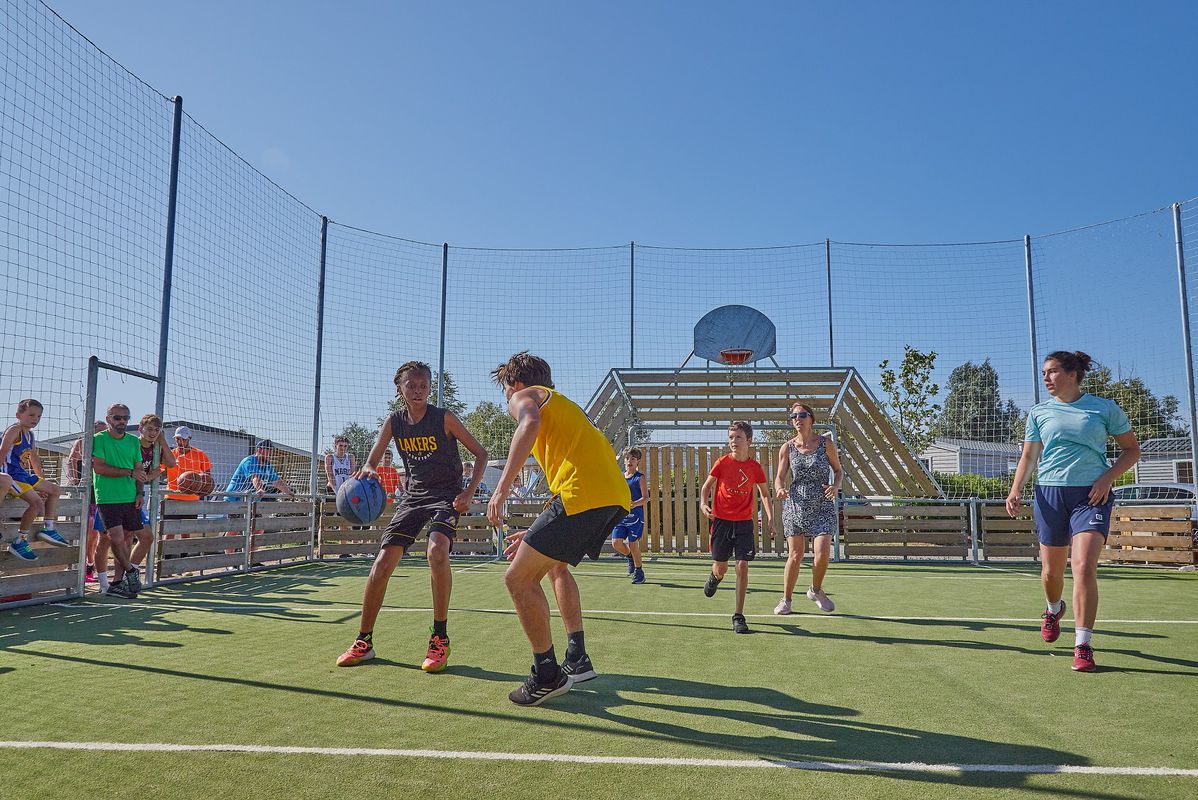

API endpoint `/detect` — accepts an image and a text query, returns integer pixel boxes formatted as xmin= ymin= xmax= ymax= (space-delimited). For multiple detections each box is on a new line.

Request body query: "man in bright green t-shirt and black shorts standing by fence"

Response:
xmin=91 ymin=402 xmax=146 ymax=598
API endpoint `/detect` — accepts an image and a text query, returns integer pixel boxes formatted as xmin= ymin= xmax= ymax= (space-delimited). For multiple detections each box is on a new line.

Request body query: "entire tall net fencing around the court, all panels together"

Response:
xmin=7 ymin=0 xmax=1198 ymax=498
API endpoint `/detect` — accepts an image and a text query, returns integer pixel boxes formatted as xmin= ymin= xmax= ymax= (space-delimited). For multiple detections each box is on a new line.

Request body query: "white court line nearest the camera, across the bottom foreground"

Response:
xmin=0 ymin=741 xmax=1198 ymax=777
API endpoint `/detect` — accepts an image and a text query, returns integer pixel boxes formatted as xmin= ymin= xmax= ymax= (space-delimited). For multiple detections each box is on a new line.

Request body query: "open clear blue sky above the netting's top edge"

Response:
xmin=44 ymin=0 xmax=1198 ymax=247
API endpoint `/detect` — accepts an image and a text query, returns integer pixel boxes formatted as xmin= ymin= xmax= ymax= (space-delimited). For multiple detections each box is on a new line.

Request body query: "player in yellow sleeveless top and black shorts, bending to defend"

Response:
xmin=486 ymin=352 xmax=633 ymax=705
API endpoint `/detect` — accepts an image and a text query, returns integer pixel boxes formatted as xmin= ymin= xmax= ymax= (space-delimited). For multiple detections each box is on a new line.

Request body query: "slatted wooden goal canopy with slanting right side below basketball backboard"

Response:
xmin=587 ymin=366 xmax=943 ymax=497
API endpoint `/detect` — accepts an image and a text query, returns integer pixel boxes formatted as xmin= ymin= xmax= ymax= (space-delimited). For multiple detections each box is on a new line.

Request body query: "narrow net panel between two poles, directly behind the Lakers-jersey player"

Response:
xmin=316 ymin=223 xmax=442 ymax=481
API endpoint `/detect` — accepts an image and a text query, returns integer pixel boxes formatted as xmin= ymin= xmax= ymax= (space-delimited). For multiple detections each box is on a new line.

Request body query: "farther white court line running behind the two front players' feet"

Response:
xmin=35 ymin=601 xmax=1198 ymax=636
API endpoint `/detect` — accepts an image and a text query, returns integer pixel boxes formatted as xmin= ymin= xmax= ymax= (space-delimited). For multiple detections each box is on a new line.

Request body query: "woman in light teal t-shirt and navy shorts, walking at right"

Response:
xmin=1006 ymin=351 xmax=1139 ymax=672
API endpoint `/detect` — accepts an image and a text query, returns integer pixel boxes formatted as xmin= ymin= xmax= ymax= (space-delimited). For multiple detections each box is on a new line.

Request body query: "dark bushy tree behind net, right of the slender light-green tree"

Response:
xmin=932 ymin=358 xmax=1023 ymax=442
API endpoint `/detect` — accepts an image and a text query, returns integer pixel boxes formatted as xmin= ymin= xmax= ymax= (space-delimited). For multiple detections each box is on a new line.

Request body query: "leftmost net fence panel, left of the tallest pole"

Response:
xmin=0 ymin=0 xmax=171 ymax=440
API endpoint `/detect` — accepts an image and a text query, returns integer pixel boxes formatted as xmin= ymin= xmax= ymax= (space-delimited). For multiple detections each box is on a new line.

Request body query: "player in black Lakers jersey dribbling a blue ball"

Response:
xmin=337 ymin=362 xmax=486 ymax=672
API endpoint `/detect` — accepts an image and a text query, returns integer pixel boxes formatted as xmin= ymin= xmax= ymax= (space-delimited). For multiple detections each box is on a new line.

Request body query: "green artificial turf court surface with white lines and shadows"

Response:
xmin=0 ymin=559 xmax=1198 ymax=800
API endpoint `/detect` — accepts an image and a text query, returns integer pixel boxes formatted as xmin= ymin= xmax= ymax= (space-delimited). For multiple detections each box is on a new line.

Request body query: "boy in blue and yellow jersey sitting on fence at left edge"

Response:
xmin=0 ymin=399 xmax=71 ymax=562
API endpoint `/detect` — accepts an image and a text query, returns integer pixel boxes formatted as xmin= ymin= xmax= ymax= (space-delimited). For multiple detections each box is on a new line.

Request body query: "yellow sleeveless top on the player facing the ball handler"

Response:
xmin=532 ymin=386 xmax=633 ymax=514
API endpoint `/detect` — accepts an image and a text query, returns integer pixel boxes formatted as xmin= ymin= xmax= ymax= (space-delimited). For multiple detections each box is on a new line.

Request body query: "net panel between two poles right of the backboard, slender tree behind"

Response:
xmin=831 ymin=241 xmax=1033 ymax=497
